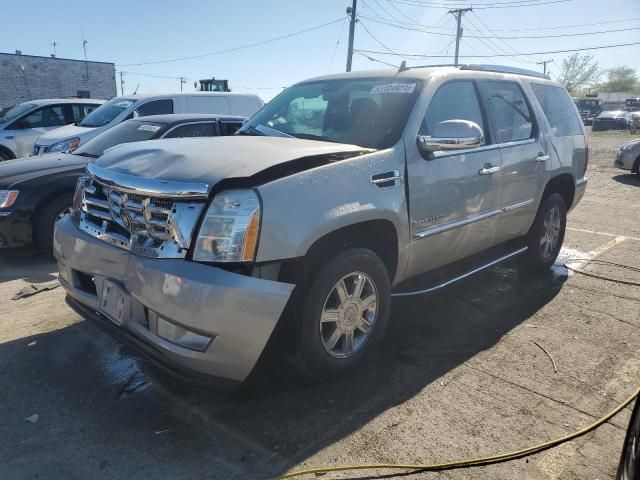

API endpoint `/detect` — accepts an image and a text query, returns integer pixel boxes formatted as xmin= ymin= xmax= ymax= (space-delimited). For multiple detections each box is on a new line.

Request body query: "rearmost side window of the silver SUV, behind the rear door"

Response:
xmin=531 ymin=83 xmax=582 ymax=137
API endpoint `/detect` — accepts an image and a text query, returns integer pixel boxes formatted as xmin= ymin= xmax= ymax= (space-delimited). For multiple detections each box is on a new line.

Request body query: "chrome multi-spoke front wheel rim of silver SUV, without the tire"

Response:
xmin=320 ymin=272 xmax=378 ymax=358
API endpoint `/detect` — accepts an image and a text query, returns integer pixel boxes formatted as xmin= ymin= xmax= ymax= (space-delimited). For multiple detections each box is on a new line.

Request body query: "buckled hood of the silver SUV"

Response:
xmin=96 ymin=135 xmax=373 ymax=186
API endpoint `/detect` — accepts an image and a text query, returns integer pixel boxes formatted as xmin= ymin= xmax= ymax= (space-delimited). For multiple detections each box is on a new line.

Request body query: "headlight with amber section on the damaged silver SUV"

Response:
xmin=193 ymin=190 xmax=261 ymax=262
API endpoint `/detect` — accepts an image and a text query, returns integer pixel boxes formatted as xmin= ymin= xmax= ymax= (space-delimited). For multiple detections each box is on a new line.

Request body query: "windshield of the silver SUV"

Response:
xmin=236 ymin=77 xmax=422 ymax=148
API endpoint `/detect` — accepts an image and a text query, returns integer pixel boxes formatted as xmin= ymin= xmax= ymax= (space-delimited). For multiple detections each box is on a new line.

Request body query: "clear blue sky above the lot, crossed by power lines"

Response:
xmin=0 ymin=0 xmax=640 ymax=99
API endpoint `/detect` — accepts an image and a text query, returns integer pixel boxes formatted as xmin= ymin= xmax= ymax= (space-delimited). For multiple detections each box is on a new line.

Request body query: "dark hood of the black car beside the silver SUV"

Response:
xmin=0 ymin=153 xmax=90 ymax=187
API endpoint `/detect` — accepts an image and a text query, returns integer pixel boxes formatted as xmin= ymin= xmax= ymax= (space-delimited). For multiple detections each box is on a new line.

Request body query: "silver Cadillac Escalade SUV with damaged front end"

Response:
xmin=54 ymin=65 xmax=588 ymax=381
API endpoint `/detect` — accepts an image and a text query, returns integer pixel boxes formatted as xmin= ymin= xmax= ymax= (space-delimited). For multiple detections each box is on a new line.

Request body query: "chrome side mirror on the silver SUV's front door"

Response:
xmin=417 ymin=120 xmax=484 ymax=156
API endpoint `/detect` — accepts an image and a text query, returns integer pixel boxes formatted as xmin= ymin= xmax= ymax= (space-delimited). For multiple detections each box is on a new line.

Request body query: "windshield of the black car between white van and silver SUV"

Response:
xmin=73 ymin=120 xmax=166 ymax=158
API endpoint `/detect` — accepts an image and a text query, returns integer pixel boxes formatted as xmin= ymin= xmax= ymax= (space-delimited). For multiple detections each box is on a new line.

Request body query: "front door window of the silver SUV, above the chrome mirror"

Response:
xmin=420 ymin=80 xmax=486 ymax=142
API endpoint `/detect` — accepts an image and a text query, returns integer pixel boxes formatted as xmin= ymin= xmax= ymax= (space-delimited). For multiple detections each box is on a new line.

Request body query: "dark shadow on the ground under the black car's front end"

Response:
xmin=0 ymin=248 xmax=58 ymax=283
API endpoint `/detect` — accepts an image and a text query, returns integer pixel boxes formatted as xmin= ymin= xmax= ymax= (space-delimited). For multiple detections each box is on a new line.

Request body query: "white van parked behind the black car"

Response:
xmin=32 ymin=92 xmax=264 ymax=155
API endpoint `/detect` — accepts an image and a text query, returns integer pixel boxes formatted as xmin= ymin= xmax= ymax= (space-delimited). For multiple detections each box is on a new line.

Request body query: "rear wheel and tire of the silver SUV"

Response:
xmin=524 ymin=193 xmax=567 ymax=272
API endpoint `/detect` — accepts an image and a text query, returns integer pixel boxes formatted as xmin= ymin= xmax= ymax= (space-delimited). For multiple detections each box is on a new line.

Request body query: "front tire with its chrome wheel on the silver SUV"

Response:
xmin=296 ymin=248 xmax=391 ymax=380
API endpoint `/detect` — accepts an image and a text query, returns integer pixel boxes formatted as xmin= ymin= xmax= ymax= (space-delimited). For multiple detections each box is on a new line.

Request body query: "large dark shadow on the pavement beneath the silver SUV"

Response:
xmin=0 ymin=263 xmax=566 ymax=479
